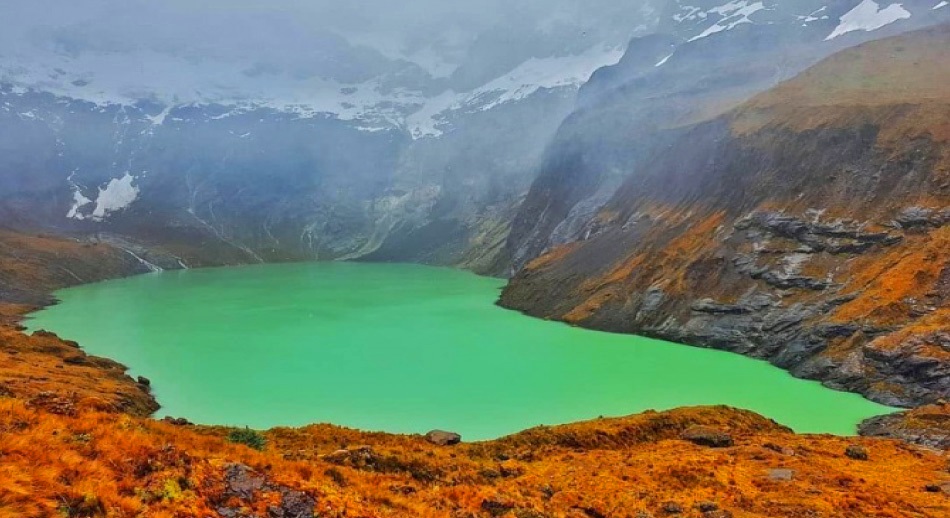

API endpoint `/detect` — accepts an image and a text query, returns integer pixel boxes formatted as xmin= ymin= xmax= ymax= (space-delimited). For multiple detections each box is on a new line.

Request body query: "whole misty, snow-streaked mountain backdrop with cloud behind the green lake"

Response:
xmin=0 ymin=0 xmax=950 ymax=275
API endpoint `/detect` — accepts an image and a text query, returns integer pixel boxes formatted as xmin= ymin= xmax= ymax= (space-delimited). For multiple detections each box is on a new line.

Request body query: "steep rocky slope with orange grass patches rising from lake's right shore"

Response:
xmin=502 ymin=26 xmax=950 ymax=405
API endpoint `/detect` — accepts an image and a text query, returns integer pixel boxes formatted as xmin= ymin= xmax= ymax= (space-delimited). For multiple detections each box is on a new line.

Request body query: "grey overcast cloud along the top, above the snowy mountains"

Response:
xmin=0 ymin=0 xmax=660 ymax=68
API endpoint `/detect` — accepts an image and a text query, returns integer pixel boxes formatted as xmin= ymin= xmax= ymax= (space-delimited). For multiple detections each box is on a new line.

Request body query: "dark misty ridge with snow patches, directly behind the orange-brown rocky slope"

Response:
xmin=510 ymin=0 xmax=950 ymax=275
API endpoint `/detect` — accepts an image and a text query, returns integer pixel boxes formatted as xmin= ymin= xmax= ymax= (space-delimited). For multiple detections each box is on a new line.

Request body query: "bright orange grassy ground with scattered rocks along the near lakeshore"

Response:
xmin=0 ymin=398 xmax=950 ymax=518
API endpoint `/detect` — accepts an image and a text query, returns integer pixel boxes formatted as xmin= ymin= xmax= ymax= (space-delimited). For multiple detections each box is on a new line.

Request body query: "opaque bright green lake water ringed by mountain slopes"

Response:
xmin=29 ymin=263 xmax=892 ymax=440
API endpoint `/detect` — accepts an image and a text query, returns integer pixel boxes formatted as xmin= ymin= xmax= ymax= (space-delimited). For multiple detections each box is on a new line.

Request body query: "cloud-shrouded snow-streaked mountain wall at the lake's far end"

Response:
xmin=0 ymin=0 xmax=658 ymax=270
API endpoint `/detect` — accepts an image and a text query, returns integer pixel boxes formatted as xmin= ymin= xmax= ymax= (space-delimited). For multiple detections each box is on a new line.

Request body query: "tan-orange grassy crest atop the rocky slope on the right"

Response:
xmin=734 ymin=25 xmax=950 ymax=141
